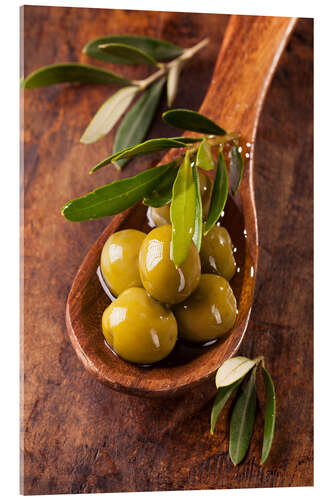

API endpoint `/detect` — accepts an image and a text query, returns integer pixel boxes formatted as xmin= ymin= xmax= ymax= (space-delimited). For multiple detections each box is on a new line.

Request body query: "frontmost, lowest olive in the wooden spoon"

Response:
xmin=102 ymin=288 xmax=177 ymax=364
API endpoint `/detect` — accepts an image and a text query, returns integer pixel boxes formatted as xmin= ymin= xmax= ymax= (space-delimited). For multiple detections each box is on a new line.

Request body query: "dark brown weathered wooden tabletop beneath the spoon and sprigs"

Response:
xmin=21 ymin=7 xmax=313 ymax=494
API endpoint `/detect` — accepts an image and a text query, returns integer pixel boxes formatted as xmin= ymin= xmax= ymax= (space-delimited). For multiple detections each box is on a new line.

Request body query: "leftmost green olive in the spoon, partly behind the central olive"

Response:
xmin=101 ymin=229 xmax=146 ymax=297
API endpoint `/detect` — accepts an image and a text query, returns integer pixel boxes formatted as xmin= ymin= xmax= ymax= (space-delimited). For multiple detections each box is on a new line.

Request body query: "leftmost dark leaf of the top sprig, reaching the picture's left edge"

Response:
xmin=22 ymin=63 xmax=131 ymax=89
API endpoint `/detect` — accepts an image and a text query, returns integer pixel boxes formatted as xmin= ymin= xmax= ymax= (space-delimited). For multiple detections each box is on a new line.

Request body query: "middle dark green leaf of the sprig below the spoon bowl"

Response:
xmin=229 ymin=368 xmax=256 ymax=465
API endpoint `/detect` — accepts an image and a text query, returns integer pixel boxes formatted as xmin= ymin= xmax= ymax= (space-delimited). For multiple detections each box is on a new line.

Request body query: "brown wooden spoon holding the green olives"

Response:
xmin=66 ymin=16 xmax=296 ymax=397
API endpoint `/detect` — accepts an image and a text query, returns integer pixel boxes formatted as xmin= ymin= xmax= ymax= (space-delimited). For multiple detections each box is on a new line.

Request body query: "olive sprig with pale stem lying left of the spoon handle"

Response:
xmin=21 ymin=35 xmax=208 ymax=169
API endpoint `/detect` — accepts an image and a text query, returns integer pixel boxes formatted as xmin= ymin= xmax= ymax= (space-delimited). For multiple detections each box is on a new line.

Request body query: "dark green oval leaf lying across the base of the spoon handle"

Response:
xmin=162 ymin=109 xmax=226 ymax=135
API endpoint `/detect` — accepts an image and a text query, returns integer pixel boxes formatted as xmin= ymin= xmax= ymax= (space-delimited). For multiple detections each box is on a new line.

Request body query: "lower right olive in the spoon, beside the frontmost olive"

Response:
xmin=173 ymin=274 xmax=237 ymax=343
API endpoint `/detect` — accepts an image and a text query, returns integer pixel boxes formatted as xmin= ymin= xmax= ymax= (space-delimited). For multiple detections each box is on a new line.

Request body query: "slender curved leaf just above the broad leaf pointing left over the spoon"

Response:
xmin=90 ymin=139 xmax=186 ymax=173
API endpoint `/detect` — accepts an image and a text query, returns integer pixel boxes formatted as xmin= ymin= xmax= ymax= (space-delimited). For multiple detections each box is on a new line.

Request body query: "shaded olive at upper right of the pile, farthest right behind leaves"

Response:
xmin=200 ymin=226 xmax=236 ymax=281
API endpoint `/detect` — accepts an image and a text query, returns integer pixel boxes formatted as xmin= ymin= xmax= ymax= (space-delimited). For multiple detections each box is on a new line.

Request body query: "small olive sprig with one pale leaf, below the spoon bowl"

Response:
xmin=210 ymin=356 xmax=276 ymax=465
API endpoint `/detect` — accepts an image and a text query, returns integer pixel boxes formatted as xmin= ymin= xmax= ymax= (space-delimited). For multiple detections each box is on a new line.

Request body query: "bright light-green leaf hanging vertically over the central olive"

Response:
xmin=170 ymin=151 xmax=196 ymax=267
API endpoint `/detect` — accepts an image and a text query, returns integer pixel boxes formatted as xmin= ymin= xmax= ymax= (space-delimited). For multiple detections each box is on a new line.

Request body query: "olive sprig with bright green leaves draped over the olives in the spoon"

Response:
xmin=62 ymin=109 xmax=244 ymax=267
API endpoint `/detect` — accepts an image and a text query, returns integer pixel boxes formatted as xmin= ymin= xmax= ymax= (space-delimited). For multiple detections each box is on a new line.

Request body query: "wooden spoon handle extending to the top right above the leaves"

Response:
xmin=200 ymin=15 xmax=297 ymax=142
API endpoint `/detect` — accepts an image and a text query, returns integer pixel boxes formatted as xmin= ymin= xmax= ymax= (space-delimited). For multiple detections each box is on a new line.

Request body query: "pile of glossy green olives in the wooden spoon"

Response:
xmin=100 ymin=174 xmax=237 ymax=364
